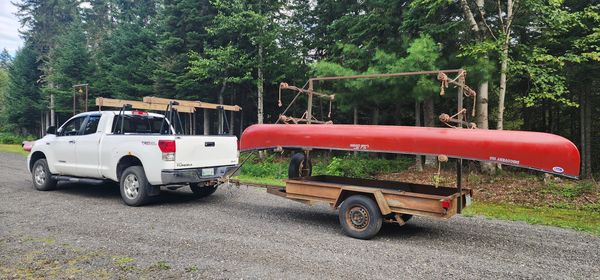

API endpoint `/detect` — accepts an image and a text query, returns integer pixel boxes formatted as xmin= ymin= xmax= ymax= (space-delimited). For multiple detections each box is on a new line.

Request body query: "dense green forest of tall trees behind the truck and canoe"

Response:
xmin=0 ymin=0 xmax=600 ymax=178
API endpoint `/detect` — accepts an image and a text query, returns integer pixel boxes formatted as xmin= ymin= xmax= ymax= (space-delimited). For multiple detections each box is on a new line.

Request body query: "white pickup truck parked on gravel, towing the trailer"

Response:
xmin=27 ymin=111 xmax=238 ymax=206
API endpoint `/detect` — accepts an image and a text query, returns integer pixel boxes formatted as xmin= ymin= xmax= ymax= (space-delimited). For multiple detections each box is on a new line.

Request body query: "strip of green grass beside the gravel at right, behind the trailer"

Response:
xmin=463 ymin=202 xmax=600 ymax=236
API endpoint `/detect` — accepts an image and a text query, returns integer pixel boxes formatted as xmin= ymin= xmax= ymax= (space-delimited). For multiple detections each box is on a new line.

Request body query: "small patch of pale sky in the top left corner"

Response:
xmin=0 ymin=0 xmax=23 ymax=56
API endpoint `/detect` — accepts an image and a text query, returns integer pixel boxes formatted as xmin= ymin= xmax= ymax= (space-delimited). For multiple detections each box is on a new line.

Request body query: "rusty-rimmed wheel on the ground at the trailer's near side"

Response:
xmin=339 ymin=195 xmax=383 ymax=239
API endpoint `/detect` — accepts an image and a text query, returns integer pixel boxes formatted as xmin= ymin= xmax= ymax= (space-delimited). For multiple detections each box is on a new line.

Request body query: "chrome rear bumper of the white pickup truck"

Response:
xmin=160 ymin=165 xmax=239 ymax=185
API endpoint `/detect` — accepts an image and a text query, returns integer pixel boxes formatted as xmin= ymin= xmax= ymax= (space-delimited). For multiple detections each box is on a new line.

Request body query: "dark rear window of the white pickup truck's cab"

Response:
xmin=112 ymin=115 xmax=170 ymax=134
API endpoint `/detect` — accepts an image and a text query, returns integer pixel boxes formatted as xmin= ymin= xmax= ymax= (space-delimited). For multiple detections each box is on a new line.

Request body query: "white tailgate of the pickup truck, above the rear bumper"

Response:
xmin=175 ymin=136 xmax=238 ymax=169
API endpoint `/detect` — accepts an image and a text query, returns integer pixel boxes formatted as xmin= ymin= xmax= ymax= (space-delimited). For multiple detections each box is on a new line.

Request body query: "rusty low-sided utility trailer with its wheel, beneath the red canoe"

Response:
xmin=258 ymin=175 xmax=473 ymax=239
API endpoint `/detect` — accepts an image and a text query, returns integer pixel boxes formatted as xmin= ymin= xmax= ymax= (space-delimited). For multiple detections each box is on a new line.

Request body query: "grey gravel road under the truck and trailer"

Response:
xmin=0 ymin=153 xmax=600 ymax=279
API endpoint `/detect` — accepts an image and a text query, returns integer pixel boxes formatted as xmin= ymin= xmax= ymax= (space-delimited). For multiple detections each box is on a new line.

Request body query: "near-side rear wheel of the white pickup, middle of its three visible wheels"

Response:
xmin=119 ymin=166 xmax=152 ymax=206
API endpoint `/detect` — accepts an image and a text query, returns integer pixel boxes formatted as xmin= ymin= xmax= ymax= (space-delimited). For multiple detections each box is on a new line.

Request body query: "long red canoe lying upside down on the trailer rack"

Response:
xmin=240 ymin=124 xmax=579 ymax=178
